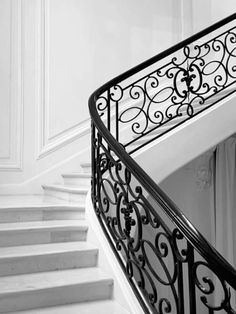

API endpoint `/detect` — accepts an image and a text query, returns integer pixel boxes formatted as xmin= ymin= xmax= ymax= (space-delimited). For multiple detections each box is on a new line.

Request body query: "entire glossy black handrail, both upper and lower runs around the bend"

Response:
xmin=89 ymin=13 xmax=236 ymax=312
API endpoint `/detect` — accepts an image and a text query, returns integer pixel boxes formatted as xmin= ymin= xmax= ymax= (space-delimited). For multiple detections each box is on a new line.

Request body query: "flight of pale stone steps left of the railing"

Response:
xmin=0 ymin=163 xmax=128 ymax=314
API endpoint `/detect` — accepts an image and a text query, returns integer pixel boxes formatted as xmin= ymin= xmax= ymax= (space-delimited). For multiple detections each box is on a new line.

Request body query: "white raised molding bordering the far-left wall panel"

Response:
xmin=0 ymin=0 xmax=24 ymax=171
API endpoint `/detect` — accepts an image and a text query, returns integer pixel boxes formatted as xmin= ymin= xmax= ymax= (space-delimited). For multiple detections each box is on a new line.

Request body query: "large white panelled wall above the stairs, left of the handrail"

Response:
xmin=0 ymin=0 xmax=183 ymax=193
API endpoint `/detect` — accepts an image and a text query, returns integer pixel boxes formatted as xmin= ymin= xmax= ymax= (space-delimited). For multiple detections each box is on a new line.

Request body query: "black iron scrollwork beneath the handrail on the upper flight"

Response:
xmin=97 ymin=27 xmax=236 ymax=152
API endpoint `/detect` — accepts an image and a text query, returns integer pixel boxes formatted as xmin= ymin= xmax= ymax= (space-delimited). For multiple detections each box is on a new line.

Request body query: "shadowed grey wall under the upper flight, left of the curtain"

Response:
xmin=160 ymin=155 xmax=214 ymax=245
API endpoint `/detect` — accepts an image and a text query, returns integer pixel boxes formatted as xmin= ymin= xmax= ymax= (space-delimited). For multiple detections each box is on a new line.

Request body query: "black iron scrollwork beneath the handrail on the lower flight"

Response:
xmin=93 ymin=131 xmax=236 ymax=314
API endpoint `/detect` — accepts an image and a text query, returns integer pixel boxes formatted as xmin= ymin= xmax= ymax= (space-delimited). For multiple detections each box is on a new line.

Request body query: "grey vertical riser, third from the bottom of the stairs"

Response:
xmin=0 ymin=228 xmax=87 ymax=247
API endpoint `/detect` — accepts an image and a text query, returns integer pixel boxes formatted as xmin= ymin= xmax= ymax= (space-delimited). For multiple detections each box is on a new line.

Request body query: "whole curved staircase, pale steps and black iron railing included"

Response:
xmin=0 ymin=14 xmax=236 ymax=314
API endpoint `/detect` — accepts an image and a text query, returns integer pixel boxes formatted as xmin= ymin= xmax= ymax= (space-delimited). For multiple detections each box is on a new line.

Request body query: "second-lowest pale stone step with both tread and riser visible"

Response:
xmin=0 ymin=242 xmax=98 ymax=280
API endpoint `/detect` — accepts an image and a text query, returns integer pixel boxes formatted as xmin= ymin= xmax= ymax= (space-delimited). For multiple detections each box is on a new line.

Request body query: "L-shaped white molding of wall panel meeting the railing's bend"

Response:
xmin=36 ymin=0 xmax=90 ymax=159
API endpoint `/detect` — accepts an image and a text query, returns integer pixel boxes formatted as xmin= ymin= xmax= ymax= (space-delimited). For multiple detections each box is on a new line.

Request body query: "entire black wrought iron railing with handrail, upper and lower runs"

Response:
xmin=89 ymin=14 xmax=236 ymax=314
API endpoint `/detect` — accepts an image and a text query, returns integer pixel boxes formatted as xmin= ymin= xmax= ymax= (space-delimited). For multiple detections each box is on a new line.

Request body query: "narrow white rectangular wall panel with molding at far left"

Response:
xmin=0 ymin=0 xmax=23 ymax=171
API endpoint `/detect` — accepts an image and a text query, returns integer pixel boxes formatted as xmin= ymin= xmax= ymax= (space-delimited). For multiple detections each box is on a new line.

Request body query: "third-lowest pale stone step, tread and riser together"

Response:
xmin=0 ymin=220 xmax=88 ymax=247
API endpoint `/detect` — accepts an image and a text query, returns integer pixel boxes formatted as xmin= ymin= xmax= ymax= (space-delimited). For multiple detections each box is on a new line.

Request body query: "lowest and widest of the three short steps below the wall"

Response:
xmin=42 ymin=184 xmax=89 ymax=203
